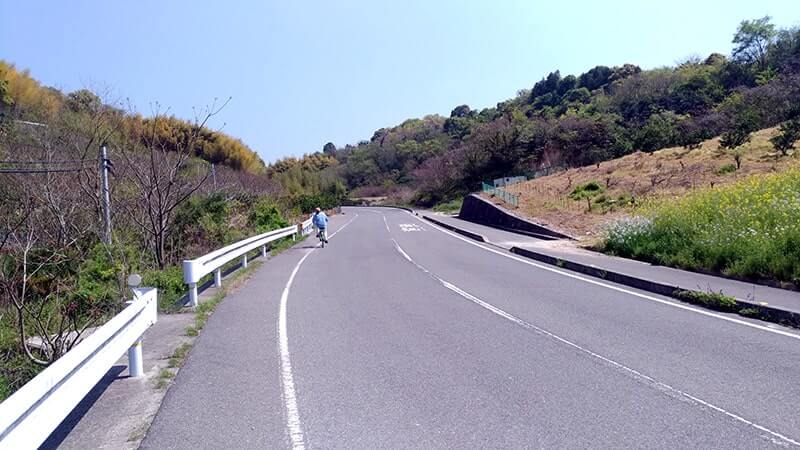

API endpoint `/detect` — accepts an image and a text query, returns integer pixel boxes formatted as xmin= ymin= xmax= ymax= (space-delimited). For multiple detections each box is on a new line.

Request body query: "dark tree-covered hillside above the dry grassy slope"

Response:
xmin=308 ymin=18 xmax=800 ymax=206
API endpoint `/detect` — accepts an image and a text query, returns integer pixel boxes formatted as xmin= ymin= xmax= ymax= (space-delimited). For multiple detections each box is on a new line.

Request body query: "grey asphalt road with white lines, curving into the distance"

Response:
xmin=142 ymin=208 xmax=800 ymax=449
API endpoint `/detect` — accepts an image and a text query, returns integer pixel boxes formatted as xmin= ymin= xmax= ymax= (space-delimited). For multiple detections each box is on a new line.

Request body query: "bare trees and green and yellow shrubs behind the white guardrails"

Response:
xmin=0 ymin=61 xmax=344 ymax=400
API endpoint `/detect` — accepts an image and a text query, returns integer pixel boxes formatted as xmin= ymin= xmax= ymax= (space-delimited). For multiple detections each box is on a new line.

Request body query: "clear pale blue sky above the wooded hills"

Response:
xmin=0 ymin=0 xmax=800 ymax=162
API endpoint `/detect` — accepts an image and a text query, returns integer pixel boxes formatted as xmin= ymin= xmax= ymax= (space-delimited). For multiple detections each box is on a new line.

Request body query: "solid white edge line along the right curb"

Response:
xmin=412 ymin=214 xmax=800 ymax=340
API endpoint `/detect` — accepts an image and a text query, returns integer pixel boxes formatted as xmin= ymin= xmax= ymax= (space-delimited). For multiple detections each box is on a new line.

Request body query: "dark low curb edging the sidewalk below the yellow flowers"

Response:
xmin=510 ymin=247 xmax=800 ymax=328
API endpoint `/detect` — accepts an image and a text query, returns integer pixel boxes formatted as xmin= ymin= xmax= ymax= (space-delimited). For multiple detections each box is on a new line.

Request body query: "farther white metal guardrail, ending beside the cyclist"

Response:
xmin=183 ymin=219 xmax=312 ymax=306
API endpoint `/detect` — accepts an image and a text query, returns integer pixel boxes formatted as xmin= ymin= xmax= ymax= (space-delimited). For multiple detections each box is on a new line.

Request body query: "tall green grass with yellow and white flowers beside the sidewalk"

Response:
xmin=604 ymin=168 xmax=800 ymax=283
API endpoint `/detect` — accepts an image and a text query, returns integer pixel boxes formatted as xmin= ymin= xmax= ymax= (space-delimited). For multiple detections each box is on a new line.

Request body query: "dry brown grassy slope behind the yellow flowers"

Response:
xmin=495 ymin=128 xmax=798 ymax=240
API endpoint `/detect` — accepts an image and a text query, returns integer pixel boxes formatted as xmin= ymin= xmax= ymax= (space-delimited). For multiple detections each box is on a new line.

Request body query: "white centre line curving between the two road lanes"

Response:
xmin=392 ymin=239 xmax=800 ymax=447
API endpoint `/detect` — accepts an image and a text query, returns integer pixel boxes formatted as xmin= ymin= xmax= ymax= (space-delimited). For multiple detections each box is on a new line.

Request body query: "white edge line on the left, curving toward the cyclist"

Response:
xmin=278 ymin=214 xmax=358 ymax=450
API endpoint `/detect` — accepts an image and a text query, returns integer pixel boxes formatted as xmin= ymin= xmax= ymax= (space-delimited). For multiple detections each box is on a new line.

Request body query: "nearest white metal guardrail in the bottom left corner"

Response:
xmin=0 ymin=288 xmax=158 ymax=449
